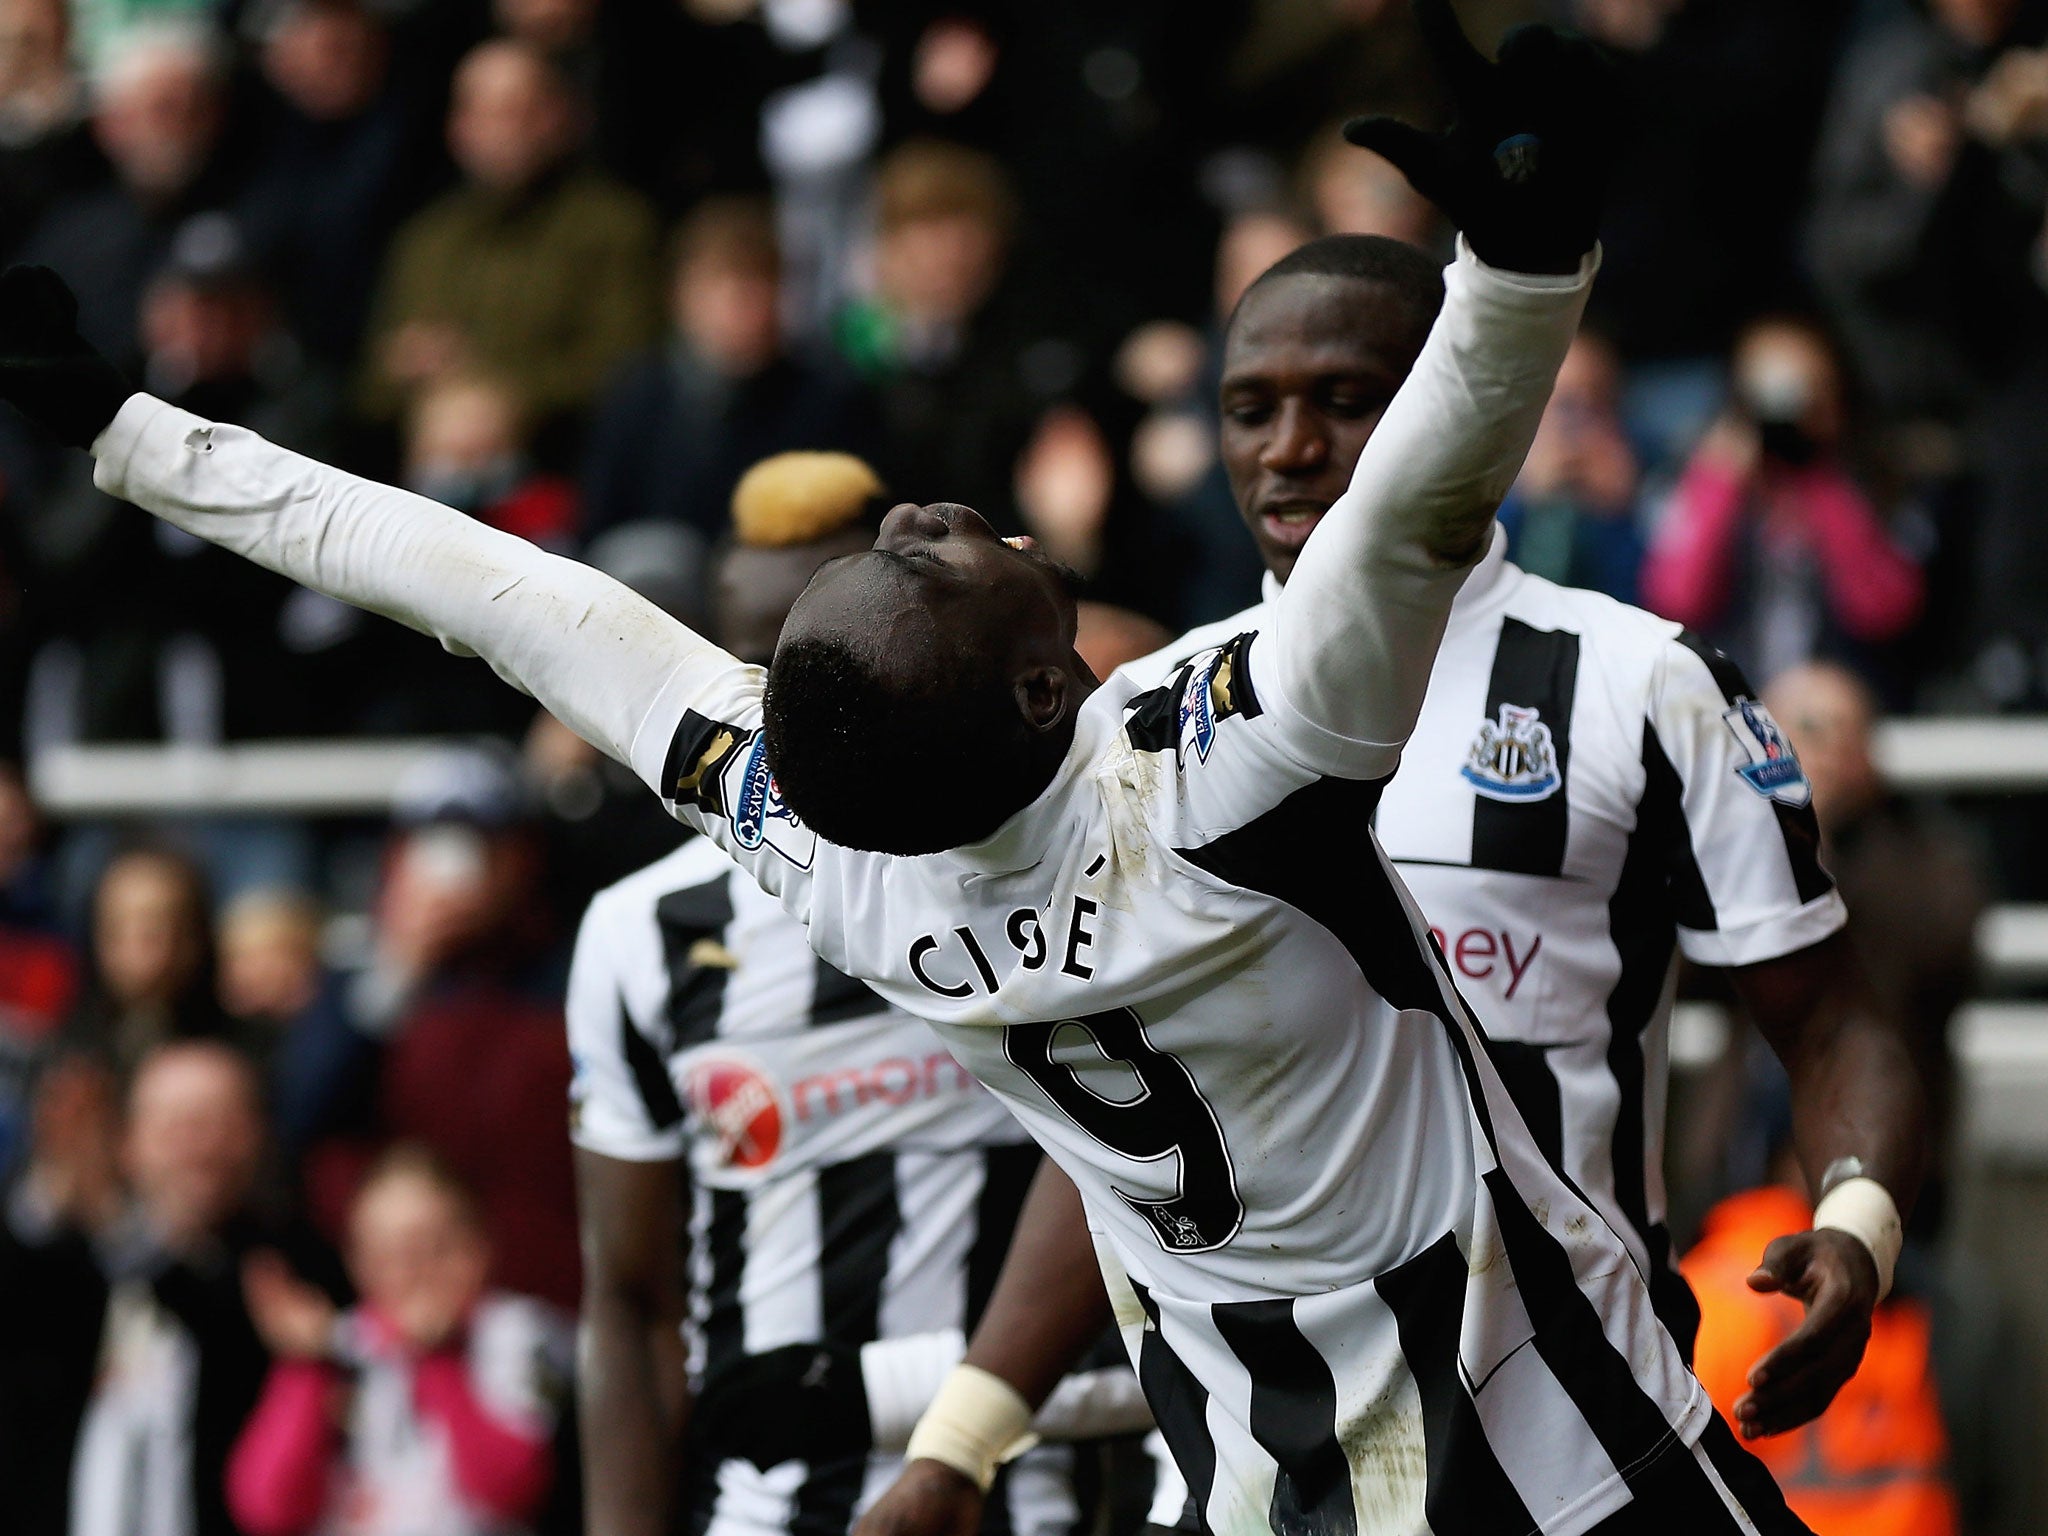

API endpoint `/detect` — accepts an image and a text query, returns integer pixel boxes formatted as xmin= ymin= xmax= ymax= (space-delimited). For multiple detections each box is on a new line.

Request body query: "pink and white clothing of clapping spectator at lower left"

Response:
xmin=227 ymin=1296 xmax=567 ymax=1536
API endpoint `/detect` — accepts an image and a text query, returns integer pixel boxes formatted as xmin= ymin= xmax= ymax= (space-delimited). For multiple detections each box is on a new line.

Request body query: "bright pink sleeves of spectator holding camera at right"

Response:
xmin=1642 ymin=455 xmax=1923 ymax=641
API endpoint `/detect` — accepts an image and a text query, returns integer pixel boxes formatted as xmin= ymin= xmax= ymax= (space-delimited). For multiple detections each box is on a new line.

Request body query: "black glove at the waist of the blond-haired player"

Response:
xmin=690 ymin=1343 xmax=874 ymax=1473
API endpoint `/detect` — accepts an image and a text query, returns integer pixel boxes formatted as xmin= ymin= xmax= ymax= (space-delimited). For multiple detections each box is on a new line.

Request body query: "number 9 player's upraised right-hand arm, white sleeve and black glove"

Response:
xmin=1268 ymin=0 xmax=1616 ymax=772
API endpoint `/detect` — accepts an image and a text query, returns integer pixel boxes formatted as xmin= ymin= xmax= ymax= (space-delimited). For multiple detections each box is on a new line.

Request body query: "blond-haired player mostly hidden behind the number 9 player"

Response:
xmin=567 ymin=455 xmax=1075 ymax=1536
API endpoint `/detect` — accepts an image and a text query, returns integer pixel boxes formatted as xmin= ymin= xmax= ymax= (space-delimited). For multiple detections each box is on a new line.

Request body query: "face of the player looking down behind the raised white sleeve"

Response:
xmin=1219 ymin=274 xmax=1427 ymax=582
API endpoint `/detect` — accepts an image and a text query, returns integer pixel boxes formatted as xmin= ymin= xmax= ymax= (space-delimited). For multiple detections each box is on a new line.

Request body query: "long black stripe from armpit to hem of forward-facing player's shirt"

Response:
xmin=1608 ymin=725 xmax=1714 ymax=1362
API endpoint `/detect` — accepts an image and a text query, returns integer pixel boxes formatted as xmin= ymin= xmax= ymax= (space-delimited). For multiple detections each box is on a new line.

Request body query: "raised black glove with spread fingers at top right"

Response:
xmin=1343 ymin=0 xmax=1622 ymax=272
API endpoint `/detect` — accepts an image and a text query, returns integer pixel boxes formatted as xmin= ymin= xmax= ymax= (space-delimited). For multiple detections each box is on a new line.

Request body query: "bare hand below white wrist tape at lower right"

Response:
xmin=1735 ymin=1227 xmax=1880 ymax=1440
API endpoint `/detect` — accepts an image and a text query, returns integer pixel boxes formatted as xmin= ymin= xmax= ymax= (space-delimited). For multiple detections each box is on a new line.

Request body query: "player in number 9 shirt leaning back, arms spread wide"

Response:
xmin=0 ymin=0 xmax=1843 ymax=1536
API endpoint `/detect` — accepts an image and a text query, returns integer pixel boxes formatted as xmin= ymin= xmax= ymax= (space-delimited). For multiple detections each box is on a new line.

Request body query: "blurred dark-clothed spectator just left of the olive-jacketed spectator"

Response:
xmin=236 ymin=0 xmax=436 ymax=371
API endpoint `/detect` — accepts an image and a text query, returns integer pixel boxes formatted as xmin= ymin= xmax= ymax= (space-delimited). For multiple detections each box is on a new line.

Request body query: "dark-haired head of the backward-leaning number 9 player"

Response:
xmin=762 ymin=502 xmax=1096 ymax=854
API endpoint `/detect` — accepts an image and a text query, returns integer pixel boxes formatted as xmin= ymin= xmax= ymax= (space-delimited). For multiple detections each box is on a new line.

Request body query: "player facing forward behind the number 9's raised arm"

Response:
xmin=823 ymin=236 xmax=1925 ymax=1530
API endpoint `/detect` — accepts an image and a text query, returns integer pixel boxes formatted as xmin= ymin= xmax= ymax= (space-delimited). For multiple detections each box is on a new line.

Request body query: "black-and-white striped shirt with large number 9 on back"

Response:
xmin=631 ymin=252 xmax=1712 ymax=1536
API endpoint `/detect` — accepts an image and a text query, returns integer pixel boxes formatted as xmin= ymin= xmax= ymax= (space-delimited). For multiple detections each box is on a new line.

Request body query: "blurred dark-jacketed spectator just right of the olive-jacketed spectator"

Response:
xmin=584 ymin=197 xmax=879 ymax=541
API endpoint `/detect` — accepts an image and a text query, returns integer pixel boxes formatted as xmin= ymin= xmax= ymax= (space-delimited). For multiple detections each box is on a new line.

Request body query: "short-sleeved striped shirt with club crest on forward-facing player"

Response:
xmin=1130 ymin=530 xmax=1847 ymax=1354
